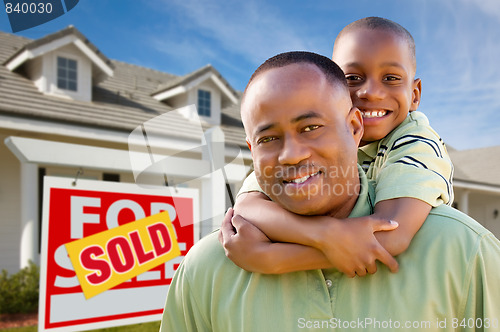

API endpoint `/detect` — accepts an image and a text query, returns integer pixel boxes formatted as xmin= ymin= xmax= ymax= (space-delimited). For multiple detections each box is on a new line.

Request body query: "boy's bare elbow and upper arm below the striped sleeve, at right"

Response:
xmin=373 ymin=197 xmax=432 ymax=256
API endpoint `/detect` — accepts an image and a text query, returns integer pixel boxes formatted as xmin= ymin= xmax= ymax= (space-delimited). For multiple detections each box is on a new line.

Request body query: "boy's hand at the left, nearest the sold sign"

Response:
xmin=219 ymin=208 xmax=274 ymax=273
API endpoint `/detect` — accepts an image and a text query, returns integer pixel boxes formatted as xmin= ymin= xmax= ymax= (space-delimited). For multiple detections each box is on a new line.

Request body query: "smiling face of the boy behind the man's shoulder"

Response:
xmin=332 ymin=28 xmax=421 ymax=144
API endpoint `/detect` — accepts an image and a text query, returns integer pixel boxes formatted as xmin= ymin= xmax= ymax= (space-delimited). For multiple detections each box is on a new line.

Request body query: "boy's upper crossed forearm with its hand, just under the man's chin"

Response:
xmin=229 ymin=192 xmax=398 ymax=276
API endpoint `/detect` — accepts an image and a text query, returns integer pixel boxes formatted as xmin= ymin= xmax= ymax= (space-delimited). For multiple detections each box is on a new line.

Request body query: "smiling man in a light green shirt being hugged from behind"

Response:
xmin=161 ymin=52 xmax=500 ymax=332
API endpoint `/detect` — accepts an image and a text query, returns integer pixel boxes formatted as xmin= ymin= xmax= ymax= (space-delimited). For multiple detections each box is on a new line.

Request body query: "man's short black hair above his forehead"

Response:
xmin=241 ymin=51 xmax=348 ymax=102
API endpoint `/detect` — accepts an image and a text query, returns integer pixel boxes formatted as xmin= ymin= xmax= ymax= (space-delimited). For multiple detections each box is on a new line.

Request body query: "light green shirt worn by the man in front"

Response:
xmin=161 ymin=174 xmax=500 ymax=332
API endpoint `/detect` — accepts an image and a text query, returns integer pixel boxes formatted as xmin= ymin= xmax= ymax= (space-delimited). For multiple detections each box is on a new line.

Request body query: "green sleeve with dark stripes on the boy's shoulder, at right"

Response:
xmin=358 ymin=111 xmax=453 ymax=207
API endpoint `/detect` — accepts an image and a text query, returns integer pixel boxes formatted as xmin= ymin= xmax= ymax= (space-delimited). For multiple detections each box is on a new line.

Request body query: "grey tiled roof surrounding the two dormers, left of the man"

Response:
xmin=0 ymin=27 xmax=246 ymax=147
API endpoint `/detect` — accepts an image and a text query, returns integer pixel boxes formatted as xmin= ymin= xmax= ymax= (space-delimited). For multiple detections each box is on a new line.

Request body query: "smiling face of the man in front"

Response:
xmin=241 ymin=63 xmax=363 ymax=216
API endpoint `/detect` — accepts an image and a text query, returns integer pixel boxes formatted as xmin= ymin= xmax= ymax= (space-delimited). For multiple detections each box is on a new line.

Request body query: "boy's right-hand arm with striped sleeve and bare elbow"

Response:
xmin=364 ymin=112 xmax=453 ymax=256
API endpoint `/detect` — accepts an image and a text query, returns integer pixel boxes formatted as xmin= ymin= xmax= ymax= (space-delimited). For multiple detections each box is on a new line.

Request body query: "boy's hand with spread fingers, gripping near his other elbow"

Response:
xmin=315 ymin=216 xmax=398 ymax=277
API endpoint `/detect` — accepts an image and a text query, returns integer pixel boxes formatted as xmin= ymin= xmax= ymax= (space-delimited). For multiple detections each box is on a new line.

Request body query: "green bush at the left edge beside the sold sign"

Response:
xmin=0 ymin=261 xmax=40 ymax=314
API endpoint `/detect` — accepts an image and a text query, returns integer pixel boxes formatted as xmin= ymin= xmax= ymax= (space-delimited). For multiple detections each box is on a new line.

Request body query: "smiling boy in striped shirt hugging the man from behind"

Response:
xmin=223 ymin=17 xmax=453 ymax=276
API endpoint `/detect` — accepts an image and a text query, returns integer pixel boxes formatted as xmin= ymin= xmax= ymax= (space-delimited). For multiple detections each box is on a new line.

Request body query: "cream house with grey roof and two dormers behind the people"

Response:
xmin=0 ymin=26 xmax=500 ymax=273
